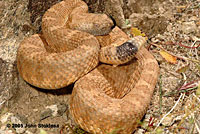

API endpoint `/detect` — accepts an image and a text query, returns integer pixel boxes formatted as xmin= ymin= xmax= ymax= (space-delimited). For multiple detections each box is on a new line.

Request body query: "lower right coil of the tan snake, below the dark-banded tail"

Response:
xmin=70 ymin=30 xmax=159 ymax=134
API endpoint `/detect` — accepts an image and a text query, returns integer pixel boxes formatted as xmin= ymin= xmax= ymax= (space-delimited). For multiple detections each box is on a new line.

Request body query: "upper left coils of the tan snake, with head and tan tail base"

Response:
xmin=17 ymin=0 xmax=142 ymax=89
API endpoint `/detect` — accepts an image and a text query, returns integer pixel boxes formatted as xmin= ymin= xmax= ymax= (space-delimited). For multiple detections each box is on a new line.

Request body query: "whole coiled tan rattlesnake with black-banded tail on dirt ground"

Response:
xmin=17 ymin=0 xmax=159 ymax=134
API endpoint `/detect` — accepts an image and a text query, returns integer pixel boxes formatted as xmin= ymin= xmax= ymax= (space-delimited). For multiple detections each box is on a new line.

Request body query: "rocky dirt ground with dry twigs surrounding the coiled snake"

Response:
xmin=0 ymin=0 xmax=200 ymax=134
